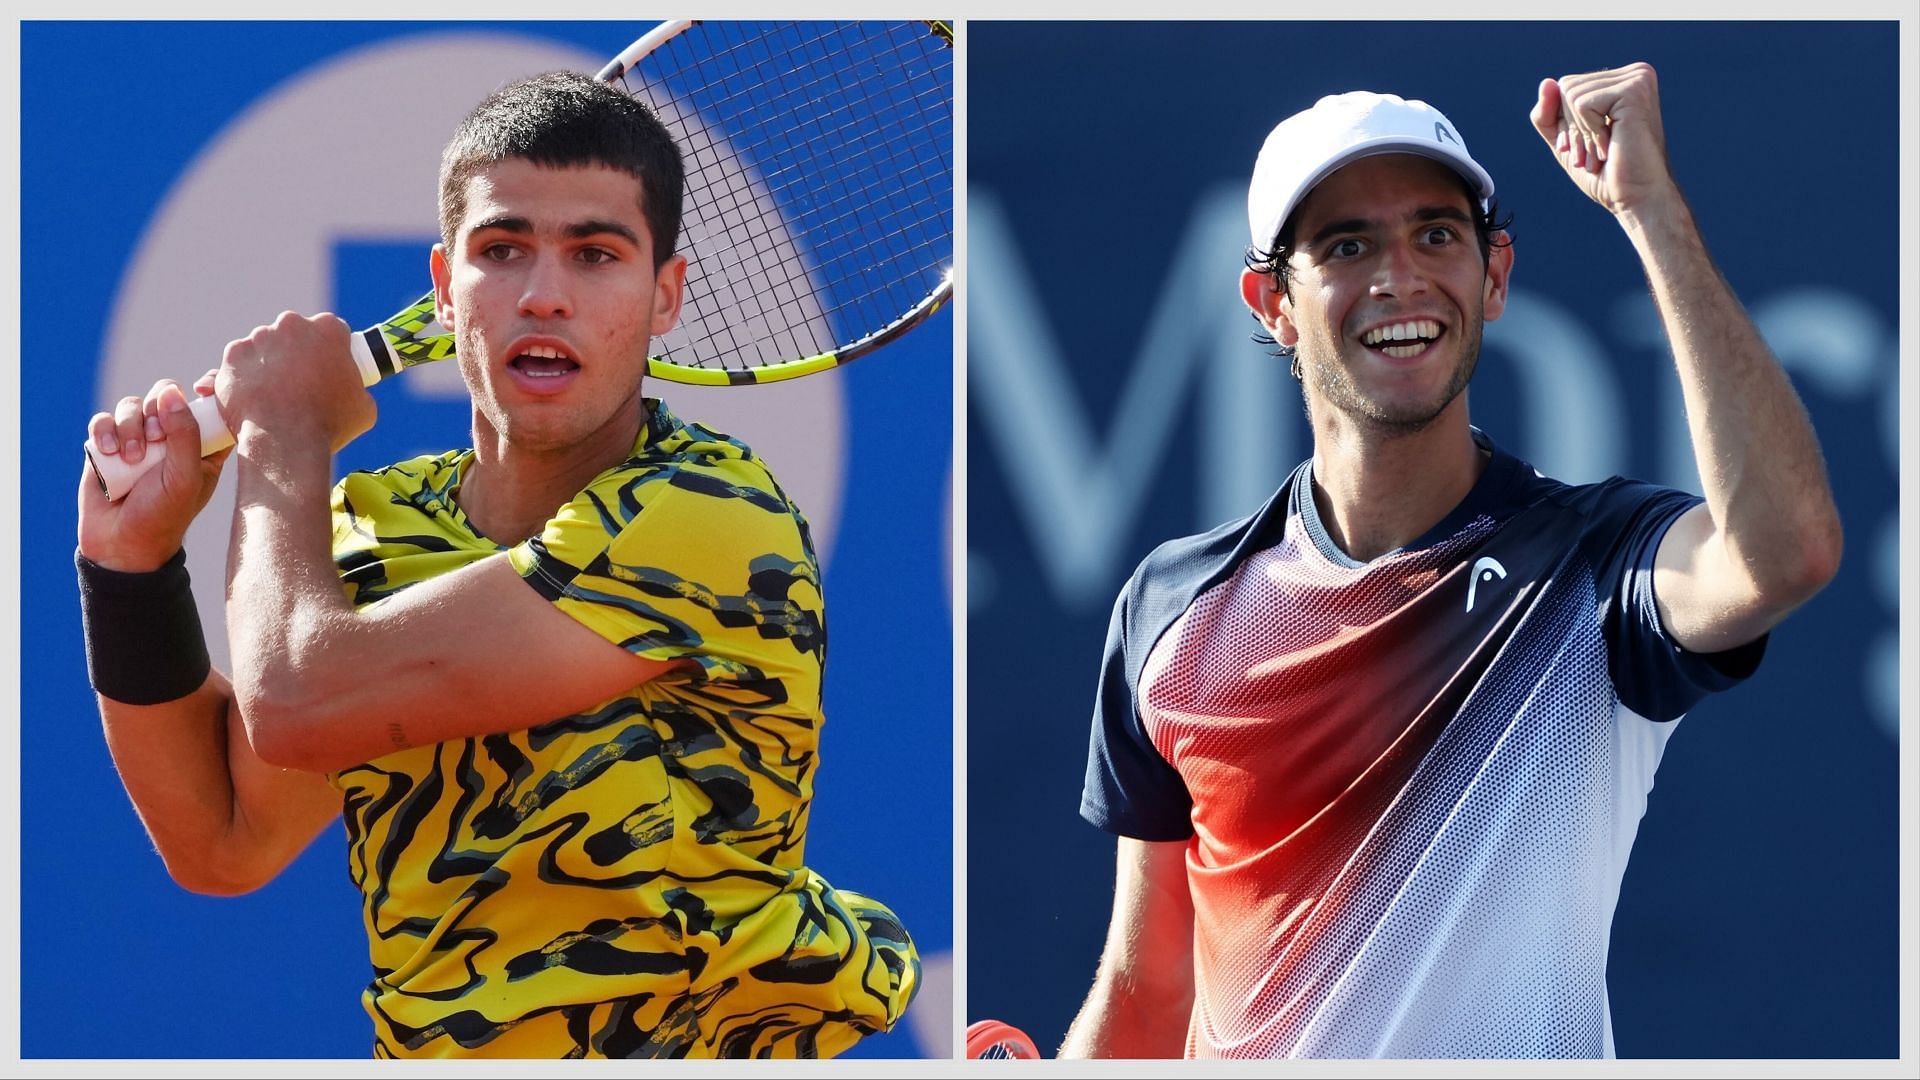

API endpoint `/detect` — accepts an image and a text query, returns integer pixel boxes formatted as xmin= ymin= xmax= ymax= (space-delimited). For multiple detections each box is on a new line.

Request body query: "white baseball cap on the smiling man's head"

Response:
xmin=1246 ymin=90 xmax=1494 ymax=252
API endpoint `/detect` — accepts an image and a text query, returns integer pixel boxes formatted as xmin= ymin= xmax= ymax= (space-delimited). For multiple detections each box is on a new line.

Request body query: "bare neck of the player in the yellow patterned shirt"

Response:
xmin=457 ymin=398 xmax=651 ymax=544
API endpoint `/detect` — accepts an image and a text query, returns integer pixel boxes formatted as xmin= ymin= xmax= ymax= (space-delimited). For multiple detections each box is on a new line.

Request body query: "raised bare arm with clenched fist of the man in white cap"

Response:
xmin=1532 ymin=63 xmax=1841 ymax=653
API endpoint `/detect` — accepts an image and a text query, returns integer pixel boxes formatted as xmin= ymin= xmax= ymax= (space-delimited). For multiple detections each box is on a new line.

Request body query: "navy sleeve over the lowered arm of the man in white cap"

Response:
xmin=1081 ymin=580 xmax=1192 ymax=840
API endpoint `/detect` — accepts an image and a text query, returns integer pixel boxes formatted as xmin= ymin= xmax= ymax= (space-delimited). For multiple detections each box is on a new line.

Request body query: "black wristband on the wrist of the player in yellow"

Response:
xmin=73 ymin=548 xmax=213 ymax=705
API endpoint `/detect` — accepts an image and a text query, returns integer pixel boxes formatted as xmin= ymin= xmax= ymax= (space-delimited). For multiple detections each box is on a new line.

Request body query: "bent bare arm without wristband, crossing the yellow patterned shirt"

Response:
xmin=221 ymin=315 xmax=674 ymax=773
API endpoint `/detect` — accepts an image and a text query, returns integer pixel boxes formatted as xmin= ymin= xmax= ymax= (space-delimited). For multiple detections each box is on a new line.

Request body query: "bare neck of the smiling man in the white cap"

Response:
xmin=1313 ymin=394 xmax=1490 ymax=563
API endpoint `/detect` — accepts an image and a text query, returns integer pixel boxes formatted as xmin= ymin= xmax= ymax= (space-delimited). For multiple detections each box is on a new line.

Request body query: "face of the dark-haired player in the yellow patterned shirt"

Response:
xmin=432 ymin=158 xmax=685 ymax=455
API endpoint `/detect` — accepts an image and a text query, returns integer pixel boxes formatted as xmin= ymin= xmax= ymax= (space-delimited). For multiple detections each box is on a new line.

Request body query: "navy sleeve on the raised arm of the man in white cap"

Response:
xmin=1590 ymin=480 xmax=1766 ymax=723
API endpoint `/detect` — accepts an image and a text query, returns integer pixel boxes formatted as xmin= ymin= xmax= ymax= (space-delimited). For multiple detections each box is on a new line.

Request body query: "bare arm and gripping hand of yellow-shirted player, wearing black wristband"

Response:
xmin=79 ymin=380 xmax=340 ymax=896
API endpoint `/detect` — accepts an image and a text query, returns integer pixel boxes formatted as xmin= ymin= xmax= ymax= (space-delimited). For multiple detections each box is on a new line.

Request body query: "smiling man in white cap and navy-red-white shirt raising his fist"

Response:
xmin=1062 ymin=63 xmax=1841 ymax=1057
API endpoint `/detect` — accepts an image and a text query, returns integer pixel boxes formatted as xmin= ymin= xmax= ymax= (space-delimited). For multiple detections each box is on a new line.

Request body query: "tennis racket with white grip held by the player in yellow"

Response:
xmin=86 ymin=21 xmax=952 ymax=500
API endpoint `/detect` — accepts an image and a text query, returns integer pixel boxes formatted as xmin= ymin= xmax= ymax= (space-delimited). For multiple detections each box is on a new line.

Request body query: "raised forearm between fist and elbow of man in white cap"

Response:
xmin=1620 ymin=192 xmax=1841 ymax=605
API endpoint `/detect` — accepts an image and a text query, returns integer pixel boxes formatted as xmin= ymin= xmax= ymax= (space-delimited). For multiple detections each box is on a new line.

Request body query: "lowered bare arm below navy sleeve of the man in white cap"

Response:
xmin=1060 ymin=836 xmax=1194 ymax=1057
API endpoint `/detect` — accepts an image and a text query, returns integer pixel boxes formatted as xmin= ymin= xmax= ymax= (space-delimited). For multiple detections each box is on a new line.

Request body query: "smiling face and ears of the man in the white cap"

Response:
xmin=1242 ymin=154 xmax=1513 ymax=434
